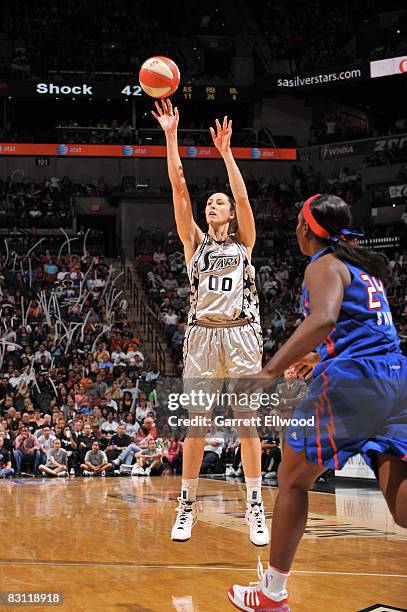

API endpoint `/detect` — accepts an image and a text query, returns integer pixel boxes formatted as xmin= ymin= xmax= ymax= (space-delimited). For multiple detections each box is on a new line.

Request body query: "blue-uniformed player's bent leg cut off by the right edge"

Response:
xmin=375 ymin=453 xmax=407 ymax=528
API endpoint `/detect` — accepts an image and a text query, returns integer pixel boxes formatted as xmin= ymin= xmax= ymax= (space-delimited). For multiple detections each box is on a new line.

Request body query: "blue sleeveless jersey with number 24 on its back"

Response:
xmin=302 ymin=247 xmax=401 ymax=362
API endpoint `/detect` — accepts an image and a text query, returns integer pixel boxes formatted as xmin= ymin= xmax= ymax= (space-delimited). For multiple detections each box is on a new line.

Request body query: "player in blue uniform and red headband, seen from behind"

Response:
xmin=229 ymin=194 xmax=407 ymax=612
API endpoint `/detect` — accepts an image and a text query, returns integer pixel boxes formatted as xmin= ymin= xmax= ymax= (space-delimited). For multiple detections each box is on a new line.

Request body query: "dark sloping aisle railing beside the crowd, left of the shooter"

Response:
xmin=122 ymin=260 xmax=167 ymax=376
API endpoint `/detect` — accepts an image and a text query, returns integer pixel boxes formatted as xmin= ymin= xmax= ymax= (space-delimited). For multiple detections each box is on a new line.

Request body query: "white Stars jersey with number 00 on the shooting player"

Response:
xmin=188 ymin=234 xmax=260 ymax=326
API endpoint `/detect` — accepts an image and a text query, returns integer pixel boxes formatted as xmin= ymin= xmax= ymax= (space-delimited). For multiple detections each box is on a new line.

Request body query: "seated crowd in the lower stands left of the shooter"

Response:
xmin=0 ymin=232 xmax=180 ymax=477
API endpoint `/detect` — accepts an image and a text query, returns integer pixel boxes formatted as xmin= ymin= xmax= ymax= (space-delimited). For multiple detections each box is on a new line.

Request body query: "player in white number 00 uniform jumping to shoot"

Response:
xmin=152 ymin=99 xmax=269 ymax=546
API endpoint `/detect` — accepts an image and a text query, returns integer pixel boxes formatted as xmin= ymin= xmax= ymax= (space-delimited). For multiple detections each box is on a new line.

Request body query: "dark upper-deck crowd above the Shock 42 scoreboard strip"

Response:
xmin=0 ymin=0 xmax=225 ymax=82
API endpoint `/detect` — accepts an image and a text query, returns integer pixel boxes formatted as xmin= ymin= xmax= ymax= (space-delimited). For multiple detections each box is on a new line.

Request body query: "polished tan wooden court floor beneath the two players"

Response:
xmin=0 ymin=477 xmax=407 ymax=612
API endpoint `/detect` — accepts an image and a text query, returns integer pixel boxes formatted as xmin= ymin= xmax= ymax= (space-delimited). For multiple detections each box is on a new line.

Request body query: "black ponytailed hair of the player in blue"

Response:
xmin=310 ymin=194 xmax=390 ymax=282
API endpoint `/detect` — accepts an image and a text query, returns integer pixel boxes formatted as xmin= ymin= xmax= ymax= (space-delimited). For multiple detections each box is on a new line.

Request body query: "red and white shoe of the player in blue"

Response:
xmin=228 ymin=559 xmax=290 ymax=612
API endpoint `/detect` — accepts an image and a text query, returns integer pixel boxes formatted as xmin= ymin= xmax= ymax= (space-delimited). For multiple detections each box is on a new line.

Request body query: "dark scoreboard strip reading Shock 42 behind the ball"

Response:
xmin=0 ymin=79 xmax=253 ymax=102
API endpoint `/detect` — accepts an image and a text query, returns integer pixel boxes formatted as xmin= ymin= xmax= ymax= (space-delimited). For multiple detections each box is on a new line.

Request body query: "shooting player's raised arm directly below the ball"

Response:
xmin=151 ymin=99 xmax=203 ymax=259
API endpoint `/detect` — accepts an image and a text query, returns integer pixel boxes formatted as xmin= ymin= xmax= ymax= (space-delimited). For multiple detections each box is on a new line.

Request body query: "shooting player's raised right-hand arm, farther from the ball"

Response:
xmin=209 ymin=117 xmax=256 ymax=249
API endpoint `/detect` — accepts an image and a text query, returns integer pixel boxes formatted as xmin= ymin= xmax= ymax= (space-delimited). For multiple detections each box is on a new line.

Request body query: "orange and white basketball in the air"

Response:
xmin=139 ymin=56 xmax=180 ymax=98
